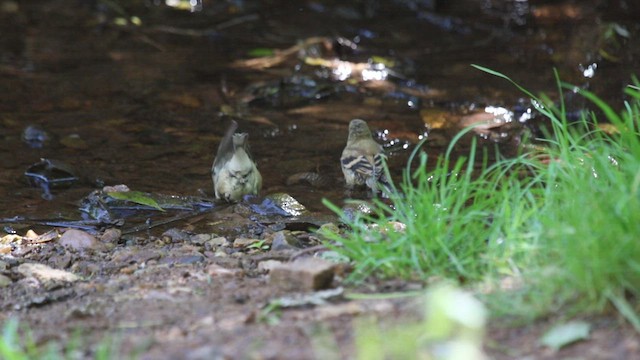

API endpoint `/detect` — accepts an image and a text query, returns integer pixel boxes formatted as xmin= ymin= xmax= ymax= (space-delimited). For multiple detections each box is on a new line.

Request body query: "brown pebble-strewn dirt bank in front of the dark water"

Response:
xmin=0 ymin=201 xmax=640 ymax=359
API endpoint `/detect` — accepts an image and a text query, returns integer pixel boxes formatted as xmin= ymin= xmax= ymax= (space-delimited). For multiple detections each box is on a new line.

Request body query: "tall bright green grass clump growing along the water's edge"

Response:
xmin=327 ymin=66 xmax=640 ymax=324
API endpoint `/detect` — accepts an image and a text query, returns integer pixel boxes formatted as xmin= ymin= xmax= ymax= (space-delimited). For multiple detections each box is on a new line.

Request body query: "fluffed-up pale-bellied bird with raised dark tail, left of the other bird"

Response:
xmin=211 ymin=120 xmax=262 ymax=202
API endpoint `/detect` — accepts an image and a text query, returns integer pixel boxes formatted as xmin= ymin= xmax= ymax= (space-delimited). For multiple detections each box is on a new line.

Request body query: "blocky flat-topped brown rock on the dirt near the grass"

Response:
xmin=269 ymin=258 xmax=334 ymax=291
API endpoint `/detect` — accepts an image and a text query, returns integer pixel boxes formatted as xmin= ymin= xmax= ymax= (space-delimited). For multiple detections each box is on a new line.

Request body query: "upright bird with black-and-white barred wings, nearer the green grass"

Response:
xmin=340 ymin=119 xmax=391 ymax=197
